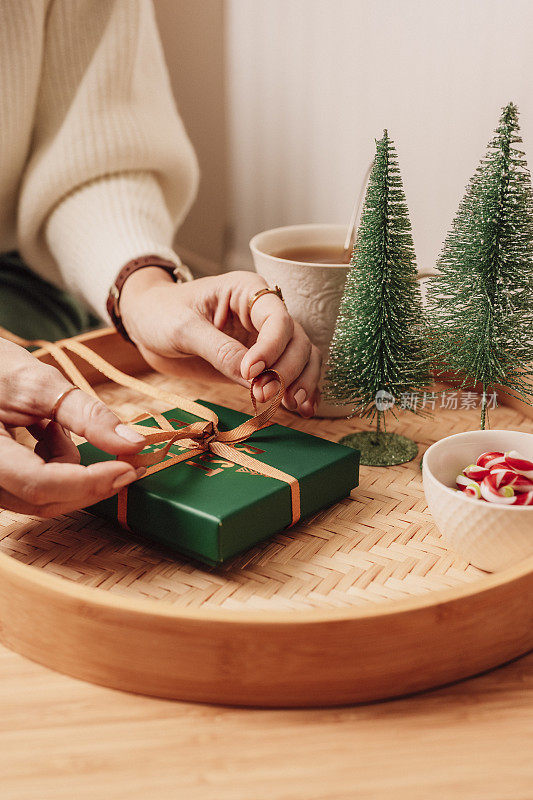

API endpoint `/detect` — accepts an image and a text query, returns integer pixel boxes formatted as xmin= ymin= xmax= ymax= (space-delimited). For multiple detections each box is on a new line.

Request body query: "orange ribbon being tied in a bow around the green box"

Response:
xmin=0 ymin=328 xmax=301 ymax=529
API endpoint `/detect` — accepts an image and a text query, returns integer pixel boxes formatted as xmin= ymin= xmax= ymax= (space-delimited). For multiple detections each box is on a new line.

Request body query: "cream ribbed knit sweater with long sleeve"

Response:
xmin=0 ymin=0 xmax=198 ymax=319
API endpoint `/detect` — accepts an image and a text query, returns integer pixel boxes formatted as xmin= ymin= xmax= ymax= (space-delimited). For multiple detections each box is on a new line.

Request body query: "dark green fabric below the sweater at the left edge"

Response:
xmin=0 ymin=252 xmax=102 ymax=342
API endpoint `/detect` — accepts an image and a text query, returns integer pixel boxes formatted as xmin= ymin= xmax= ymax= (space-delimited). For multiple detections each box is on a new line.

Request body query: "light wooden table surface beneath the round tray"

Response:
xmin=0 ymin=644 xmax=533 ymax=800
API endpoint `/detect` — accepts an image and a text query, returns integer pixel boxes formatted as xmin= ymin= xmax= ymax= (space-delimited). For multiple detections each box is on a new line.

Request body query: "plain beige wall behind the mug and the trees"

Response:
xmin=155 ymin=0 xmax=533 ymax=271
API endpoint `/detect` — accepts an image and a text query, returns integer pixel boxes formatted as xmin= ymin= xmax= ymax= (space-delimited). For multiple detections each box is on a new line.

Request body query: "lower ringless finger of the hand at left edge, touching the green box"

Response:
xmin=0 ymin=431 xmax=144 ymax=517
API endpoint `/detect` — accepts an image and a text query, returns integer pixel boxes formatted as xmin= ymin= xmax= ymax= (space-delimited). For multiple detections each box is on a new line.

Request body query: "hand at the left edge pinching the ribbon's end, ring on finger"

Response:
xmin=0 ymin=339 xmax=144 ymax=517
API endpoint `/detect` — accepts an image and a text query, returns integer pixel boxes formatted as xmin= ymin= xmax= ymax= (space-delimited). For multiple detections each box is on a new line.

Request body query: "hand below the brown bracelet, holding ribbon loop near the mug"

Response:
xmin=120 ymin=267 xmax=321 ymax=417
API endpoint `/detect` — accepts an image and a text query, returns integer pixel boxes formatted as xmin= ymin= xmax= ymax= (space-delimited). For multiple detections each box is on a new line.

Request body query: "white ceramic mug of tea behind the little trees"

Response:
xmin=250 ymin=223 xmax=431 ymax=417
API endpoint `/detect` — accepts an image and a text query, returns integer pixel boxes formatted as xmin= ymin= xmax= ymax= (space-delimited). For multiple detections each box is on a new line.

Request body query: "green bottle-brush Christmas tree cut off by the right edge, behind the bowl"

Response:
xmin=429 ymin=103 xmax=533 ymax=428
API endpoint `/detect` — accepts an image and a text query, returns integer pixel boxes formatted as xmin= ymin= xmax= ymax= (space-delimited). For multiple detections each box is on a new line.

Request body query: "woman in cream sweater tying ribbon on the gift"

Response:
xmin=0 ymin=0 xmax=320 ymax=516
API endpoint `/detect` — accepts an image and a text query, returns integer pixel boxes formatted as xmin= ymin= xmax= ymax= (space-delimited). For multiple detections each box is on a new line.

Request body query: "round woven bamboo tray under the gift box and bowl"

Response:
xmin=0 ymin=332 xmax=533 ymax=706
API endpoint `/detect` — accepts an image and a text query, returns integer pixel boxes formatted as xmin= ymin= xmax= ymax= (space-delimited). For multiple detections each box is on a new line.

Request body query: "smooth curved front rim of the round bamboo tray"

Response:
xmin=0 ymin=331 xmax=533 ymax=708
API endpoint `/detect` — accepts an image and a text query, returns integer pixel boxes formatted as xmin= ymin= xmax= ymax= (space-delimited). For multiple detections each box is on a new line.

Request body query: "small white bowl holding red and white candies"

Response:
xmin=422 ymin=430 xmax=533 ymax=572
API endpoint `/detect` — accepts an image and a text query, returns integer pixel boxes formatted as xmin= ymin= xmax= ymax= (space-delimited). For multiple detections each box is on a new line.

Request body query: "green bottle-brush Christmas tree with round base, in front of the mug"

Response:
xmin=325 ymin=131 xmax=431 ymax=466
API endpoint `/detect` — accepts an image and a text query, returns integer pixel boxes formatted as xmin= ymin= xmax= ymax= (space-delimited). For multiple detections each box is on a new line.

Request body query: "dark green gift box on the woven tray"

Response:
xmin=79 ymin=400 xmax=359 ymax=566
